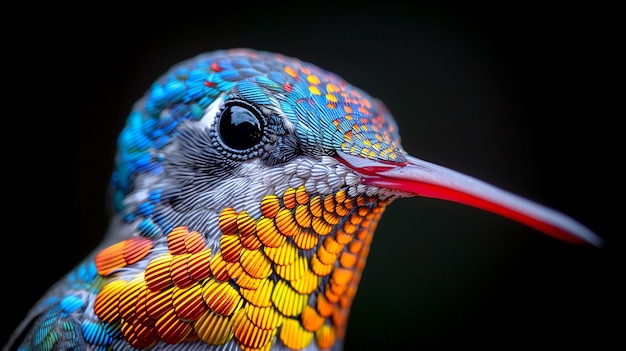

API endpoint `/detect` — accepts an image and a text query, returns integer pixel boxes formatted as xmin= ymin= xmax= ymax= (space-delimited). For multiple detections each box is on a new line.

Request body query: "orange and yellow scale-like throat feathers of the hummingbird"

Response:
xmin=94 ymin=186 xmax=391 ymax=350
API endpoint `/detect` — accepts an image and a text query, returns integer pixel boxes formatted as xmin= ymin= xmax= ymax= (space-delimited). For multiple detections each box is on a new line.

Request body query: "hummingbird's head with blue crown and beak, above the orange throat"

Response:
xmin=111 ymin=49 xmax=601 ymax=245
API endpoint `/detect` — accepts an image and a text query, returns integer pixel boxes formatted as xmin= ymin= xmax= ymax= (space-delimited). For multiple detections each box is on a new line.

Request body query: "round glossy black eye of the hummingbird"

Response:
xmin=220 ymin=105 xmax=263 ymax=150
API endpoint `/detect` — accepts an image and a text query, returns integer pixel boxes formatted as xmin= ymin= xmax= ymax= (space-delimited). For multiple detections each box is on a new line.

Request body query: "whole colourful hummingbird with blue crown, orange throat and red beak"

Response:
xmin=3 ymin=48 xmax=603 ymax=351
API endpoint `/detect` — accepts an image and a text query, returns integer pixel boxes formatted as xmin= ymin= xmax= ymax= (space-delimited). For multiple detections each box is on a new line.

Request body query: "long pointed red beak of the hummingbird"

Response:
xmin=337 ymin=152 xmax=604 ymax=247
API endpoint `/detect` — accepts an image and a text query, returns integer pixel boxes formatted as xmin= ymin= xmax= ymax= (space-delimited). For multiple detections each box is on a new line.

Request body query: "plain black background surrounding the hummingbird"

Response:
xmin=3 ymin=1 xmax=624 ymax=350
